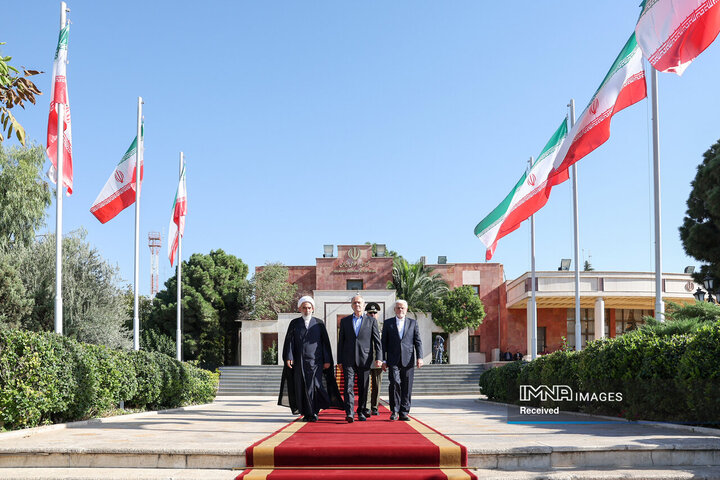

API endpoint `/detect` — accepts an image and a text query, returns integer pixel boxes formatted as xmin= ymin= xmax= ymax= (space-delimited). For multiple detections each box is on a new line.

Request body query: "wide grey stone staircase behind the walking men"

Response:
xmin=218 ymin=364 xmax=487 ymax=396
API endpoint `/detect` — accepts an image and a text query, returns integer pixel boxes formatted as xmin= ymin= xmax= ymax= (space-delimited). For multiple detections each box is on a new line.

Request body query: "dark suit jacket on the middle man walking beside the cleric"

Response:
xmin=338 ymin=315 xmax=381 ymax=368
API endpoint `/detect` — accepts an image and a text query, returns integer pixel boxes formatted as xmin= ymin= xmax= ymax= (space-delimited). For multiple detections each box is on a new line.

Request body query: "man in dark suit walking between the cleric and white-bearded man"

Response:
xmin=338 ymin=295 xmax=381 ymax=423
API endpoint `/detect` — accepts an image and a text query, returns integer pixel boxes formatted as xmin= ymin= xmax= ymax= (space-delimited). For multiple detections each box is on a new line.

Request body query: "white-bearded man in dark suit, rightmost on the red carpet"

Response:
xmin=382 ymin=300 xmax=423 ymax=421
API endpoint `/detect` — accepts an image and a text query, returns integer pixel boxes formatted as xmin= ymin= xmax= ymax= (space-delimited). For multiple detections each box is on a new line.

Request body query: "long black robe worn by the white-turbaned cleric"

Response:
xmin=278 ymin=317 xmax=343 ymax=416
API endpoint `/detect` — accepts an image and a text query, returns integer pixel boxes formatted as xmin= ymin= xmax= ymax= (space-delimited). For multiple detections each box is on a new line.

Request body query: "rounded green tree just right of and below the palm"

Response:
xmin=430 ymin=285 xmax=485 ymax=333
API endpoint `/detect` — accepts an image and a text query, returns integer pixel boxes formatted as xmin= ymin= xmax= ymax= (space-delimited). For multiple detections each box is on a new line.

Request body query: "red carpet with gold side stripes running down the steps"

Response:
xmin=237 ymin=406 xmax=476 ymax=480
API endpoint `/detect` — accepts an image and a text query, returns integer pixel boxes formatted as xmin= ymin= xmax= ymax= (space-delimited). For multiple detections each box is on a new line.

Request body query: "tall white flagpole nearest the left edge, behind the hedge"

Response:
xmin=51 ymin=2 xmax=67 ymax=335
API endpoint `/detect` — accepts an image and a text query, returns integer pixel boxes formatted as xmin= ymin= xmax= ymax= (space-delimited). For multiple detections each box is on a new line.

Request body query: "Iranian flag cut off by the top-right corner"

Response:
xmin=635 ymin=0 xmax=720 ymax=75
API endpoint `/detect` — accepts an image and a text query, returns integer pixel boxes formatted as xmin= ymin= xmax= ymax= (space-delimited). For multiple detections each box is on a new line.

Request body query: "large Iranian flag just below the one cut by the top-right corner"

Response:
xmin=548 ymin=33 xmax=647 ymax=188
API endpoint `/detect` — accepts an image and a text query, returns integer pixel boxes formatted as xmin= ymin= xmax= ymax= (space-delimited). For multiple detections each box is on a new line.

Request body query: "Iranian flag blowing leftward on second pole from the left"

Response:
xmin=90 ymin=131 xmax=144 ymax=223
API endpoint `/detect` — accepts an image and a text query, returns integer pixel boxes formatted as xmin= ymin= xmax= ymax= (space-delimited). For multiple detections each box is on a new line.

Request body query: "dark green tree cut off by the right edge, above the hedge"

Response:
xmin=680 ymin=141 xmax=720 ymax=285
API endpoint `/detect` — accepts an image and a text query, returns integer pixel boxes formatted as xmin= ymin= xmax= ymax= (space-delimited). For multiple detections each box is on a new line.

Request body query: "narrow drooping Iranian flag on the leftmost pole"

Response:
xmin=46 ymin=24 xmax=73 ymax=196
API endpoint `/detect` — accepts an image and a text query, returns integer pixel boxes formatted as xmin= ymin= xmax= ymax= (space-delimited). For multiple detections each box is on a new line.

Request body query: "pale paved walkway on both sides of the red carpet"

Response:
xmin=0 ymin=395 xmax=720 ymax=478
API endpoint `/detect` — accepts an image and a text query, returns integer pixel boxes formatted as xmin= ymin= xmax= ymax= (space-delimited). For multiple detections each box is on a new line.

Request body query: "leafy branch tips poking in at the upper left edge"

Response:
xmin=0 ymin=42 xmax=42 ymax=145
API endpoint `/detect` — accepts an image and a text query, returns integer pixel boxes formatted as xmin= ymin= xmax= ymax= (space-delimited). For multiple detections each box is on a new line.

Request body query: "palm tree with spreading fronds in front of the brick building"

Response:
xmin=388 ymin=257 xmax=449 ymax=313
